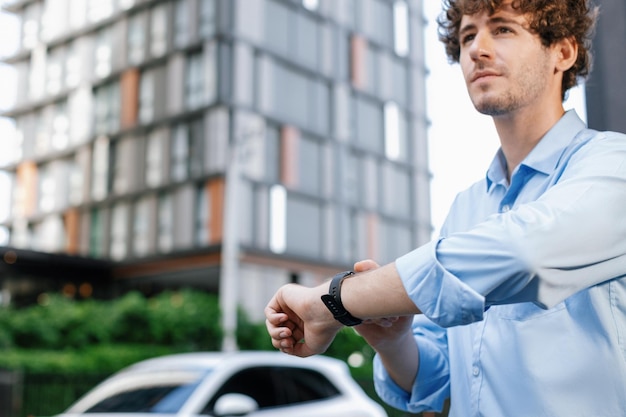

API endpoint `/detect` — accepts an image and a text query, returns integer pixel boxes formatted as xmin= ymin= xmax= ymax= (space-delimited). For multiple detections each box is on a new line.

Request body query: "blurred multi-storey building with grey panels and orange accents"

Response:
xmin=0 ymin=0 xmax=431 ymax=344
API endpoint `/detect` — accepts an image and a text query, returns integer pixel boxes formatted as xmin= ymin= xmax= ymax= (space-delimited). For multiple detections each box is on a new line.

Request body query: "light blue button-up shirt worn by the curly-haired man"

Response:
xmin=374 ymin=111 xmax=626 ymax=417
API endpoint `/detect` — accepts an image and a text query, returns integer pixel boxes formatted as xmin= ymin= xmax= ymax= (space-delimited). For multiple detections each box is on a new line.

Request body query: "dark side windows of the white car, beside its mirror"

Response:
xmin=201 ymin=366 xmax=339 ymax=415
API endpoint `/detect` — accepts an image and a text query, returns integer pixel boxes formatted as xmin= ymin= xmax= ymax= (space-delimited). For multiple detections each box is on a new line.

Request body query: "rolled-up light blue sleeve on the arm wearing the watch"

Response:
xmin=396 ymin=130 xmax=626 ymax=327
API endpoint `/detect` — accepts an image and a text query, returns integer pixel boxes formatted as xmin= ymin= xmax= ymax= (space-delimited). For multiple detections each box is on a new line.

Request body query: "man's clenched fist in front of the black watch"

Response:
xmin=265 ymin=283 xmax=342 ymax=357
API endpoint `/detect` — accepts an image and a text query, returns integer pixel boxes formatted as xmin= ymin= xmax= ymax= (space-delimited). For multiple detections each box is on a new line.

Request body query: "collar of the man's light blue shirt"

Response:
xmin=486 ymin=110 xmax=586 ymax=191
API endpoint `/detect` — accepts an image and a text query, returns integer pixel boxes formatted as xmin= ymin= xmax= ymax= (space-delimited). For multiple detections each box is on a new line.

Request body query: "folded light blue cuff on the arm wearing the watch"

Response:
xmin=396 ymin=241 xmax=485 ymax=327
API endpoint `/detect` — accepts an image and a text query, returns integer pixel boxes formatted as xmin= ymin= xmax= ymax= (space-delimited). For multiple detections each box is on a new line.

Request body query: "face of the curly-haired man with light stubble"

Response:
xmin=459 ymin=1 xmax=560 ymax=116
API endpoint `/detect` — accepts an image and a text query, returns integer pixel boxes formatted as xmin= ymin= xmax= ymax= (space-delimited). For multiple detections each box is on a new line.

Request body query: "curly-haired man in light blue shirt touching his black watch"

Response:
xmin=266 ymin=0 xmax=626 ymax=417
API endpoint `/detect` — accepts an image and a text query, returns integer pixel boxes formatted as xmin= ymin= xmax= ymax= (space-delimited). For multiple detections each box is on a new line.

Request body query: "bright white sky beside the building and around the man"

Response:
xmin=0 ymin=0 xmax=586 ymax=245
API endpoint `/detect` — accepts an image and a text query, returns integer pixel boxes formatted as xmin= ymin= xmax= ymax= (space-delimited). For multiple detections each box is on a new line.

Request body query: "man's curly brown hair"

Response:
xmin=437 ymin=0 xmax=598 ymax=98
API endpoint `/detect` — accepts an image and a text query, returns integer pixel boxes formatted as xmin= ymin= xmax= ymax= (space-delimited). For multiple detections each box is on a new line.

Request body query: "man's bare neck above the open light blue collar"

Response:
xmin=493 ymin=103 xmax=565 ymax=180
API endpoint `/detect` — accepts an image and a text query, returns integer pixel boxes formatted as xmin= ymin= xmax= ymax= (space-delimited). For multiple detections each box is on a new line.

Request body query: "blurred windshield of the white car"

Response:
xmin=74 ymin=370 xmax=207 ymax=413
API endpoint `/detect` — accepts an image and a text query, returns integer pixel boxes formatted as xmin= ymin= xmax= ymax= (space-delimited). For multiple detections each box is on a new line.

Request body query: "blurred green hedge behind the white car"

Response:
xmin=0 ymin=290 xmax=372 ymax=375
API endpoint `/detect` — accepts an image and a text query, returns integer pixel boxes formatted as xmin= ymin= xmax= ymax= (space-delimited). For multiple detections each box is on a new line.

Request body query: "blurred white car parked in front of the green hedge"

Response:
xmin=59 ymin=352 xmax=387 ymax=417
